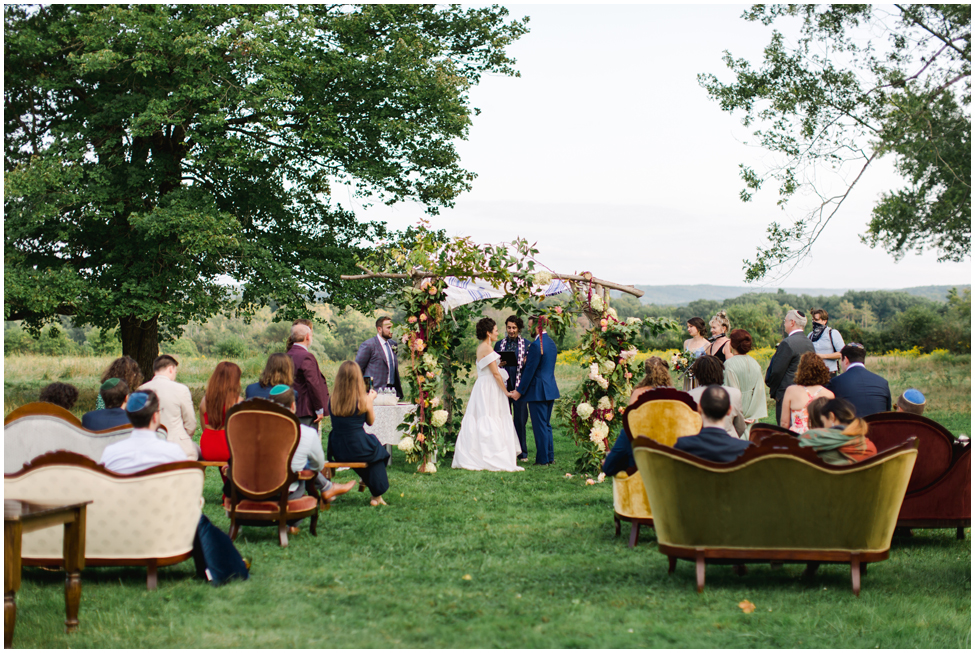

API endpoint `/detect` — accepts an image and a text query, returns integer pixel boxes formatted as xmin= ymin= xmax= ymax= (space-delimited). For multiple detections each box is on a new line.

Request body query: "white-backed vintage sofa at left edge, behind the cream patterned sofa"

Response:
xmin=3 ymin=401 xmax=132 ymax=474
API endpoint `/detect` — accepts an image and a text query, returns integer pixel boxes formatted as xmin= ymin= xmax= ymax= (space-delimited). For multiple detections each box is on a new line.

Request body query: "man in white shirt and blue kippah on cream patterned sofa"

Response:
xmin=99 ymin=390 xmax=186 ymax=474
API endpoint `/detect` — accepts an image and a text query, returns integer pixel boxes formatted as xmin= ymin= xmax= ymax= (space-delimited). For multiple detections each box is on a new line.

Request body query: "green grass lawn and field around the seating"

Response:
xmin=4 ymin=358 xmax=971 ymax=648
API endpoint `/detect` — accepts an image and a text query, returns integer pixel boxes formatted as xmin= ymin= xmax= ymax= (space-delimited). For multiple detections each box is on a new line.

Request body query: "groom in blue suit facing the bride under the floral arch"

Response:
xmin=513 ymin=315 xmax=559 ymax=465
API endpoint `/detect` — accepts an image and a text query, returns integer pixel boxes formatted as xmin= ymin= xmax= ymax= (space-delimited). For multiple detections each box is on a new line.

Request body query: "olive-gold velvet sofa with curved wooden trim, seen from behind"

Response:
xmin=633 ymin=435 xmax=917 ymax=596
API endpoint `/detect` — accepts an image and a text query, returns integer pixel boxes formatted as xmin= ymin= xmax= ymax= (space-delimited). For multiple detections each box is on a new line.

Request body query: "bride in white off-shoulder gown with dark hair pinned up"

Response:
xmin=451 ymin=317 xmax=524 ymax=472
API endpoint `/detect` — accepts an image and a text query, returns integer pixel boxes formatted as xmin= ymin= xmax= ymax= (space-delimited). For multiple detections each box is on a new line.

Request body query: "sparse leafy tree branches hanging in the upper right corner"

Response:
xmin=698 ymin=4 xmax=972 ymax=280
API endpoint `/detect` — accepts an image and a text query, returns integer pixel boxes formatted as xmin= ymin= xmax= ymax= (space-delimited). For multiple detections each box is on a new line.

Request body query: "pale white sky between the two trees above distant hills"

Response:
xmin=353 ymin=5 xmax=971 ymax=289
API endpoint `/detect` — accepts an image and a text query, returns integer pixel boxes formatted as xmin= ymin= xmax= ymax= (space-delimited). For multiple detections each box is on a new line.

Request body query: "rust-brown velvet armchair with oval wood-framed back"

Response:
xmin=224 ymin=399 xmax=319 ymax=546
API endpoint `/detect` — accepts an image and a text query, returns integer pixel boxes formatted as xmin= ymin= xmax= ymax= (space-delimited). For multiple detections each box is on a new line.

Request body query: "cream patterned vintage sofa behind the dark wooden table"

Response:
xmin=3 ymin=451 xmax=204 ymax=589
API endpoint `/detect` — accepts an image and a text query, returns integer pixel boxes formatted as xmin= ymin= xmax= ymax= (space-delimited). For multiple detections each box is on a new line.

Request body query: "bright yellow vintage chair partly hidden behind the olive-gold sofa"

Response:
xmin=613 ymin=388 xmax=701 ymax=549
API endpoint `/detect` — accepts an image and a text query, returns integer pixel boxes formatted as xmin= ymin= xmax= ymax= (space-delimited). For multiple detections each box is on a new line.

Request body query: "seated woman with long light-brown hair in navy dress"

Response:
xmin=328 ymin=361 xmax=389 ymax=506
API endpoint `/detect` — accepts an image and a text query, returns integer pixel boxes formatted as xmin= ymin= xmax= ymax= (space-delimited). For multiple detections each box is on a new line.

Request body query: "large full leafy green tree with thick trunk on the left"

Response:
xmin=4 ymin=5 xmax=527 ymax=370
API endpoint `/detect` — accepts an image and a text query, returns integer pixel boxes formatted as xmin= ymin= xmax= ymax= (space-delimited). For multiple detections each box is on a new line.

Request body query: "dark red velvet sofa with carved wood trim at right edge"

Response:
xmin=864 ymin=412 xmax=972 ymax=539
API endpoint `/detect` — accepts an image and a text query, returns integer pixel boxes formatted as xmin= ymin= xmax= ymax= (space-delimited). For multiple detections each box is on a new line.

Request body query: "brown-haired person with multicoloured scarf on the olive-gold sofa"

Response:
xmin=799 ymin=398 xmax=877 ymax=465
